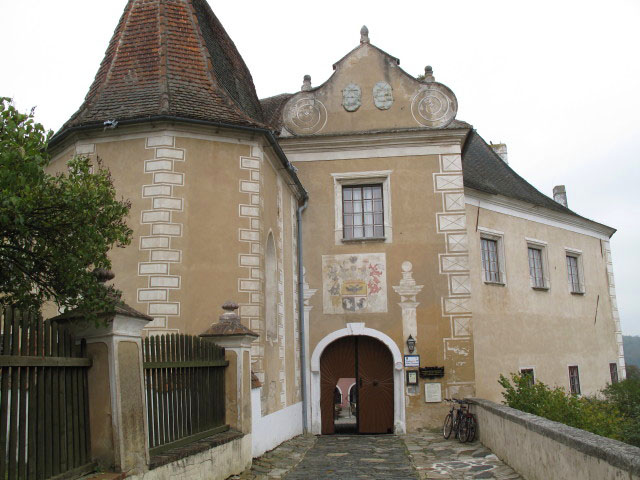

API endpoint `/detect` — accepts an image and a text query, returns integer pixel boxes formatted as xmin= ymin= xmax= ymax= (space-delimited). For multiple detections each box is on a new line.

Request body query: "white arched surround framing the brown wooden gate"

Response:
xmin=310 ymin=323 xmax=406 ymax=435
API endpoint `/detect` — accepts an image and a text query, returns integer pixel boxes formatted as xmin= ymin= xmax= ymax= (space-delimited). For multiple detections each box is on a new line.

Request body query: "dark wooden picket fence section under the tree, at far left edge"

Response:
xmin=0 ymin=307 xmax=95 ymax=480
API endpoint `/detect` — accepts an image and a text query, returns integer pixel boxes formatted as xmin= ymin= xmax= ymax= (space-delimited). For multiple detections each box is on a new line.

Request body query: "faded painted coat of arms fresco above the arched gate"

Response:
xmin=322 ymin=253 xmax=387 ymax=314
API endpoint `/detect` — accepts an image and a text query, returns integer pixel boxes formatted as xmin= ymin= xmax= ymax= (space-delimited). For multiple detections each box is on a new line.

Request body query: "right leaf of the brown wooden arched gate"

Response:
xmin=358 ymin=337 xmax=393 ymax=433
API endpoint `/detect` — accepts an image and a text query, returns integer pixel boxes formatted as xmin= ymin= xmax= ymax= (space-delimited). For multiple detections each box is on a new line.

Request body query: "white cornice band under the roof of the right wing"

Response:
xmin=464 ymin=188 xmax=615 ymax=240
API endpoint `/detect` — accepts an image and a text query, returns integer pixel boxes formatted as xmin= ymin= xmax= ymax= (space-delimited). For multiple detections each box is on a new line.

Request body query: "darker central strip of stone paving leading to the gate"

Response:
xmin=284 ymin=435 xmax=418 ymax=480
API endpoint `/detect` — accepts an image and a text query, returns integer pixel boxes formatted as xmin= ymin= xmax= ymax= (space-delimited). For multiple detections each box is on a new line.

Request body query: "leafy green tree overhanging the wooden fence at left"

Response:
xmin=0 ymin=98 xmax=132 ymax=312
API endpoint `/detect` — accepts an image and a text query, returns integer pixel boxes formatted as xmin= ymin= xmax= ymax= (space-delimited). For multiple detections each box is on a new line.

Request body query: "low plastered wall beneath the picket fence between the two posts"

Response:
xmin=127 ymin=434 xmax=251 ymax=480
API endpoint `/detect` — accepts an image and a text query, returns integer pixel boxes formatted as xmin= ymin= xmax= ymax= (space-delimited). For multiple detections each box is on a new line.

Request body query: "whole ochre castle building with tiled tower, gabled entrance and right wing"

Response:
xmin=51 ymin=0 xmax=625 ymax=455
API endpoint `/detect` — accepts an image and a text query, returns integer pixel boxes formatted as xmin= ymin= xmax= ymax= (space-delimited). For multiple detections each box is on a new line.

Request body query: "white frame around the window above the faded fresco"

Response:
xmin=331 ymin=170 xmax=393 ymax=245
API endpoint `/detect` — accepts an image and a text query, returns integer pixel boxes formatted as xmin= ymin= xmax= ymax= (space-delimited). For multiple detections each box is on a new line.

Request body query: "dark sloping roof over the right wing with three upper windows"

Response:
xmin=462 ymin=130 xmax=611 ymax=232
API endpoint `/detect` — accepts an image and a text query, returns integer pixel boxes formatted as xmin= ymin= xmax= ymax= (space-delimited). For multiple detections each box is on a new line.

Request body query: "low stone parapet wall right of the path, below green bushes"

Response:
xmin=469 ymin=398 xmax=640 ymax=480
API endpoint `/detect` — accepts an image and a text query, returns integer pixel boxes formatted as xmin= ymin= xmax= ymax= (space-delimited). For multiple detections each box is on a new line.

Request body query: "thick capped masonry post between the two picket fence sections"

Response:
xmin=51 ymin=302 xmax=153 ymax=474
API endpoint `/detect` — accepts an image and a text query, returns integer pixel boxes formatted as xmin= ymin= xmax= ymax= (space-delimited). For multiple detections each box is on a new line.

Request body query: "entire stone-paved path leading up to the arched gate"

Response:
xmin=231 ymin=432 xmax=522 ymax=480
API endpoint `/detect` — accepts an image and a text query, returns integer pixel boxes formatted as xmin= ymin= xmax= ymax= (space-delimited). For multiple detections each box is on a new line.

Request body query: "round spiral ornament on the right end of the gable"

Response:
xmin=411 ymin=82 xmax=458 ymax=128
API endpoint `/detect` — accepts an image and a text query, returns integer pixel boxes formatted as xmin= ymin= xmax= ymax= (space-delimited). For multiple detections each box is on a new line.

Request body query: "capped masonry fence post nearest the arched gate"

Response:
xmin=200 ymin=302 xmax=258 ymax=434
